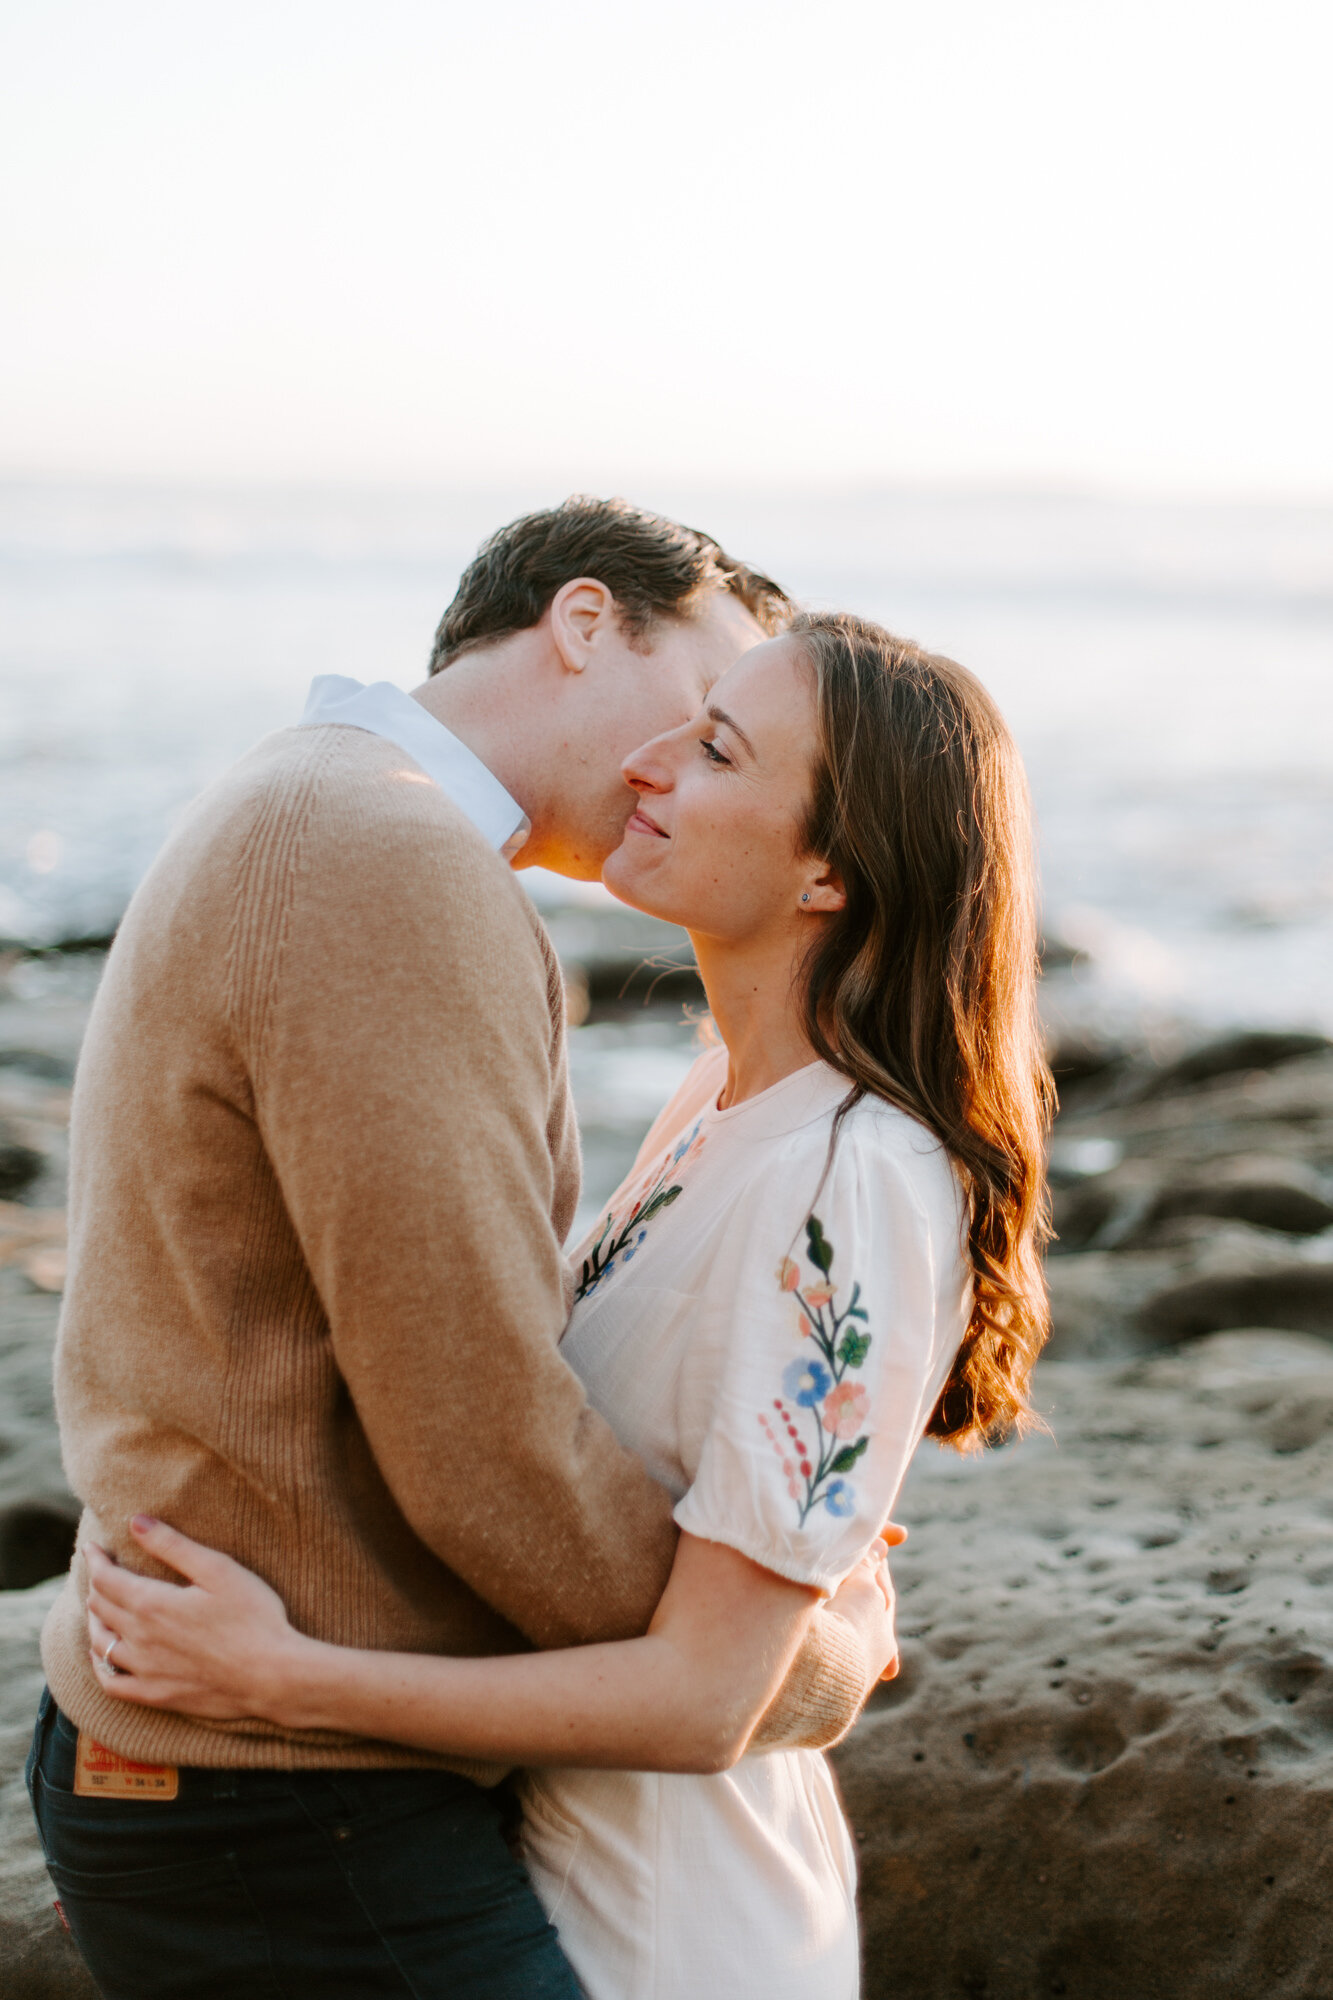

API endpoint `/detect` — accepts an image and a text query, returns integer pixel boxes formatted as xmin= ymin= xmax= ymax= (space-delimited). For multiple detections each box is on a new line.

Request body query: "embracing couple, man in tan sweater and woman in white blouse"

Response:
xmin=28 ymin=498 xmax=1051 ymax=2000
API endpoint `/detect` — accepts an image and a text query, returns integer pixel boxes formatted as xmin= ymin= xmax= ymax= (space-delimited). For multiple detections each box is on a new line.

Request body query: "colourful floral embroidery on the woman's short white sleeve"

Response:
xmin=759 ymin=1216 xmax=871 ymax=1526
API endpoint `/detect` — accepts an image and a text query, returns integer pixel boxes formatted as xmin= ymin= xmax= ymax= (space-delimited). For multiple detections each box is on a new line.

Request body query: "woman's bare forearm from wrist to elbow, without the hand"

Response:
xmin=276 ymin=1632 xmax=787 ymax=1772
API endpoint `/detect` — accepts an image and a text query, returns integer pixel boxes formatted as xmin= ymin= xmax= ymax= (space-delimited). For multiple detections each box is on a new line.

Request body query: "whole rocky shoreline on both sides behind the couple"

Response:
xmin=0 ymin=956 xmax=1333 ymax=2000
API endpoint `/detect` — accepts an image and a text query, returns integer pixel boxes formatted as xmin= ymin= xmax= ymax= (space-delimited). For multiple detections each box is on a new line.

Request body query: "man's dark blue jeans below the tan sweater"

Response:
xmin=28 ymin=1692 xmax=578 ymax=2000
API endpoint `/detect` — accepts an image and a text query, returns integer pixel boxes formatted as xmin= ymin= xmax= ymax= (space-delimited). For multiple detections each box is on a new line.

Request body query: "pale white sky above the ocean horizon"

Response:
xmin=0 ymin=0 xmax=1333 ymax=496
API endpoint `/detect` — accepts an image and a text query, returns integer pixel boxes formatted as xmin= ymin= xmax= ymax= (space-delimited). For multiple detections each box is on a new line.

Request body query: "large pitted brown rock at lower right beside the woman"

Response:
xmin=837 ymin=1330 xmax=1333 ymax=2000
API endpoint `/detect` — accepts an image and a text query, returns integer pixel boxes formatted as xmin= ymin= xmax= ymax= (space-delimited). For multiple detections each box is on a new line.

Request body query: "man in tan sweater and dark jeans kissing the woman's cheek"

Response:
xmin=30 ymin=500 xmax=891 ymax=2000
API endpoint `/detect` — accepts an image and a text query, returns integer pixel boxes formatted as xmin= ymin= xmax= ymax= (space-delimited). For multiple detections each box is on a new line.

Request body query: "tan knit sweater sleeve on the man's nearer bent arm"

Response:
xmin=234 ymin=768 xmax=675 ymax=1646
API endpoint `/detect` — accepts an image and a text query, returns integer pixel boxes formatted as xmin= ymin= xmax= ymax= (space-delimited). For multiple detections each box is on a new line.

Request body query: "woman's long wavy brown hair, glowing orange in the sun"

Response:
xmin=791 ymin=616 xmax=1055 ymax=1450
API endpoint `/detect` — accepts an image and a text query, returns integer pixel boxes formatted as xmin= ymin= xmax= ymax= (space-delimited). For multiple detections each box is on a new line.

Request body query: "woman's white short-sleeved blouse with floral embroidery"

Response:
xmin=524 ymin=1050 xmax=971 ymax=2000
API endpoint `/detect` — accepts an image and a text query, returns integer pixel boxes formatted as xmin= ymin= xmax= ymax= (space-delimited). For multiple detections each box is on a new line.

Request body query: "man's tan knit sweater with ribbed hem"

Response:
xmin=42 ymin=726 xmax=865 ymax=1780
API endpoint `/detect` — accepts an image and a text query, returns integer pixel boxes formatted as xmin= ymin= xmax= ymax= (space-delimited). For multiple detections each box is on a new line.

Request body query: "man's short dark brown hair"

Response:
xmin=430 ymin=494 xmax=795 ymax=674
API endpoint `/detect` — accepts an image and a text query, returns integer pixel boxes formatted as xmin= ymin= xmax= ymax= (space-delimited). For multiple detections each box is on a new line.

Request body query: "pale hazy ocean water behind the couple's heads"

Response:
xmin=0 ymin=484 xmax=1333 ymax=1056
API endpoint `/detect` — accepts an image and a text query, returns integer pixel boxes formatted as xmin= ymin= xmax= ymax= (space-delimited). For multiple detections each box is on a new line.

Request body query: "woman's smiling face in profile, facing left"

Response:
xmin=602 ymin=638 xmax=841 ymax=942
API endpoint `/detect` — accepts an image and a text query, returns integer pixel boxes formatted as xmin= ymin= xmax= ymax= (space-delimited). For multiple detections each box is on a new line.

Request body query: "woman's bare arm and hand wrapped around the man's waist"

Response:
xmin=93 ymin=1522 xmax=844 ymax=1772
